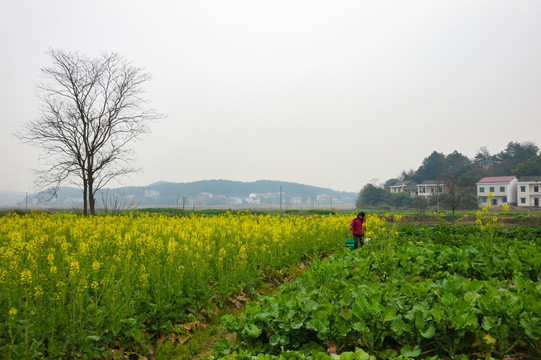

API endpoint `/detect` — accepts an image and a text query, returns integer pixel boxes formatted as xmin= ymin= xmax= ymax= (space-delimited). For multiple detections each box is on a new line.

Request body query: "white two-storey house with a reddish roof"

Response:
xmin=476 ymin=175 xmax=518 ymax=206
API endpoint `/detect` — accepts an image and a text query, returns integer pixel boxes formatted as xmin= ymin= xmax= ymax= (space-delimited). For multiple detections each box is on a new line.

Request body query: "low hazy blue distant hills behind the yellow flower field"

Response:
xmin=0 ymin=180 xmax=357 ymax=209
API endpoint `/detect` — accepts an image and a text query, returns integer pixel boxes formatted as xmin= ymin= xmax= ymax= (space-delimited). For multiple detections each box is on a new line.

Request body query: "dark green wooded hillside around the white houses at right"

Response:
xmin=356 ymin=142 xmax=541 ymax=213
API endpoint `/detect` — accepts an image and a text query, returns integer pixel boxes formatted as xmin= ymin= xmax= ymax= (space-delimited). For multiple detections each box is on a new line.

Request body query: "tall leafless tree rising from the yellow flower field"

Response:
xmin=15 ymin=50 xmax=160 ymax=215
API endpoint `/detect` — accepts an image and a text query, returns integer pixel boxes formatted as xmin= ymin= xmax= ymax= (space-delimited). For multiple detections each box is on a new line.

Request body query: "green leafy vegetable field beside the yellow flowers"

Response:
xmin=214 ymin=225 xmax=541 ymax=360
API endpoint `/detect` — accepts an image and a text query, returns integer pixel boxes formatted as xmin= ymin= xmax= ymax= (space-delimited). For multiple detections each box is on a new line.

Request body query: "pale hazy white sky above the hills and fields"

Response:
xmin=0 ymin=0 xmax=541 ymax=192
